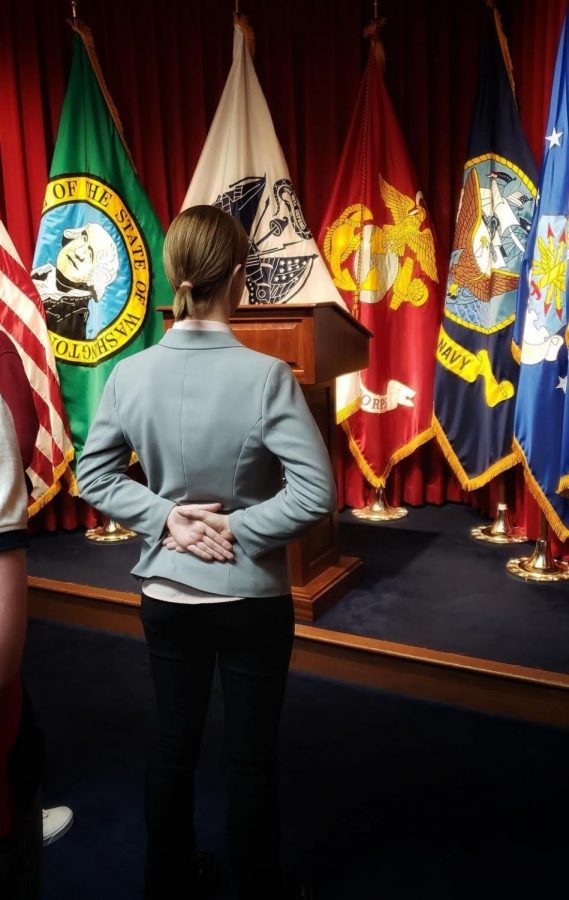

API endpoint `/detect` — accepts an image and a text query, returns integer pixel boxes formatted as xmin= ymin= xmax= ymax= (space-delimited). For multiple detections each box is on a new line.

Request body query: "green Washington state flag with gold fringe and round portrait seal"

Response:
xmin=32 ymin=26 xmax=166 ymax=456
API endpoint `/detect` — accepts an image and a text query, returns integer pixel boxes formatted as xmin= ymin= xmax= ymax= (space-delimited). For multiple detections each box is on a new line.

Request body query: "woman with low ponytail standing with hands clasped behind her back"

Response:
xmin=78 ymin=206 xmax=335 ymax=900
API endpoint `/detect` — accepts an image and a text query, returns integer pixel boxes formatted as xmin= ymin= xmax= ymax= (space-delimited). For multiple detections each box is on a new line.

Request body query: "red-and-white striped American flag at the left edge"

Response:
xmin=0 ymin=221 xmax=75 ymax=516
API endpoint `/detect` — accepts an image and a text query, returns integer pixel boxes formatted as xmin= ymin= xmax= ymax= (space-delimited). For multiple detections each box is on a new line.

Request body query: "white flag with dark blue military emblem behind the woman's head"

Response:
xmin=182 ymin=25 xmax=346 ymax=309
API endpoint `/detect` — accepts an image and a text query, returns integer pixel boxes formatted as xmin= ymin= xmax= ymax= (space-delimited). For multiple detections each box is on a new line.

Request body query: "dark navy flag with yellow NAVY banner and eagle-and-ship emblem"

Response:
xmin=433 ymin=9 xmax=537 ymax=491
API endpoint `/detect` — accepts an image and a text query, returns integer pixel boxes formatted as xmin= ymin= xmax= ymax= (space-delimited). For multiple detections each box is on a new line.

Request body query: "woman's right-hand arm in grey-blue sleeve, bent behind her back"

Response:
xmin=224 ymin=361 xmax=336 ymax=558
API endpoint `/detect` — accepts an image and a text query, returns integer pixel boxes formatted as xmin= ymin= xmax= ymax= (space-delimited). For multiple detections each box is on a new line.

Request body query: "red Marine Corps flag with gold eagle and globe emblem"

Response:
xmin=319 ymin=23 xmax=441 ymax=505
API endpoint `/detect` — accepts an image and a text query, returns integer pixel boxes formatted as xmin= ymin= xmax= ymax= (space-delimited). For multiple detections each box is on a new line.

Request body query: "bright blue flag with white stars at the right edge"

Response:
xmin=515 ymin=15 xmax=569 ymax=541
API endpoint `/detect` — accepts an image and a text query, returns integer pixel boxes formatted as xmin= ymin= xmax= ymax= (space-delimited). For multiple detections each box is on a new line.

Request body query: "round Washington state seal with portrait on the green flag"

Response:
xmin=32 ymin=174 xmax=151 ymax=366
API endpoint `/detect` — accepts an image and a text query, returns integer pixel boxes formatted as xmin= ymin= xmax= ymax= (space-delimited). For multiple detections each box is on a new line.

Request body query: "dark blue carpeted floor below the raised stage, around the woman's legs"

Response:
xmin=21 ymin=621 xmax=569 ymax=900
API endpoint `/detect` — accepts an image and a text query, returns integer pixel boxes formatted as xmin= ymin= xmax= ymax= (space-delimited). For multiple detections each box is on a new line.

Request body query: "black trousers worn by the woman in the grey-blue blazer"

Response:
xmin=141 ymin=594 xmax=294 ymax=900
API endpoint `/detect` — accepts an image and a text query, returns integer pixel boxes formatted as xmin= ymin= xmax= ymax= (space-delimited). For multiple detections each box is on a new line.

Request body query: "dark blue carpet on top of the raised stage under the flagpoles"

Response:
xmin=29 ymin=504 xmax=569 ymax=673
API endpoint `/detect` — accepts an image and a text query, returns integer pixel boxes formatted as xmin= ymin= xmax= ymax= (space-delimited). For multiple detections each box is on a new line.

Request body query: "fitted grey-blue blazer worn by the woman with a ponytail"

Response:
xmin=77 ymin=329 xmax=336 ymax=597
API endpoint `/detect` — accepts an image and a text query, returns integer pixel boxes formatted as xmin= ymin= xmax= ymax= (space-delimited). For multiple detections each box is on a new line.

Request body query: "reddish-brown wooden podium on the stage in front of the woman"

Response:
xmin=160 ymin=302 xmax=371 ymax=622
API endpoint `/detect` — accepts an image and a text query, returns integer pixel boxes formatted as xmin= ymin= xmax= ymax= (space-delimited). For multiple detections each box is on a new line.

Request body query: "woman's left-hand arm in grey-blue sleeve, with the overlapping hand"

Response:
xmin=77 ymin=367 xmax=233 ymax=561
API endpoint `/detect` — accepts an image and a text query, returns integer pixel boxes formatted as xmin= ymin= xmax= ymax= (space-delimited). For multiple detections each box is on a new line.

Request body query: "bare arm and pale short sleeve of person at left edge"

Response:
xmin=0 ymin=397 xmax=28 ymax=688
